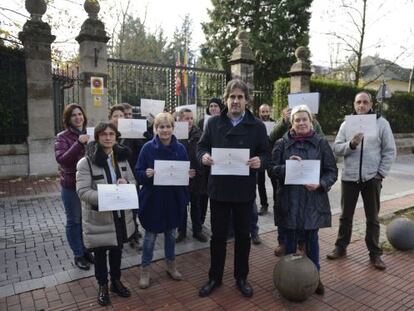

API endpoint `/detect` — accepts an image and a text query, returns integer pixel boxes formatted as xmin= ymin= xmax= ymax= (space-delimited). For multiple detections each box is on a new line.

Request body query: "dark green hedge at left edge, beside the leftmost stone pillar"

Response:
xmin=0 ymin=46 xmax=27 ymax=144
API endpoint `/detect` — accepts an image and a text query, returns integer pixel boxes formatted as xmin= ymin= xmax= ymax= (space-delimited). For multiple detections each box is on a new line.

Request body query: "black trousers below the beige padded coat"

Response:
xmin=94 ymin=248 xmax=122 ymax=286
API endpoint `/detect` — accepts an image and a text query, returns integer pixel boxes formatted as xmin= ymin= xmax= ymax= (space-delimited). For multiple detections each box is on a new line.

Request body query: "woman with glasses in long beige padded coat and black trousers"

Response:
xmin=76 ymin=123 xmax=136 ymax=306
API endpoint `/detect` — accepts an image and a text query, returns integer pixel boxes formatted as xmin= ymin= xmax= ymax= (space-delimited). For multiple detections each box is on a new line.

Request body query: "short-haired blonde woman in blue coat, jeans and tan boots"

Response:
xmin=135 ymin=113 xmax=193 ymax=288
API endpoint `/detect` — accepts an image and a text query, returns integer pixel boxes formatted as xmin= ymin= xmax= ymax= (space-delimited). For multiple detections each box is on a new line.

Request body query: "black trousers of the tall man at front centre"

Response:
xmin=208 ymin=199 xmax=252 ymax=282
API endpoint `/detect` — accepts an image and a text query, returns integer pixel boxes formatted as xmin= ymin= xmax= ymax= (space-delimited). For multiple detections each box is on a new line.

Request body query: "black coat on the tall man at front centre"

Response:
xmin=197 ymin=108 xmax=270 ymax=202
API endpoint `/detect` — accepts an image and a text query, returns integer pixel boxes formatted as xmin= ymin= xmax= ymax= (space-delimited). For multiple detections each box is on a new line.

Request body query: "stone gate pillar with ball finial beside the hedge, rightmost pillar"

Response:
xmin=289 ymin=46 xmax=312 ymax=93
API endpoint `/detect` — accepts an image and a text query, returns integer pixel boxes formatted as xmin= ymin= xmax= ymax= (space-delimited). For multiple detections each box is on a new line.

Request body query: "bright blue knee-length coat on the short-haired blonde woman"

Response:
xmin=135 ymin=135 xmax=190 ymax=233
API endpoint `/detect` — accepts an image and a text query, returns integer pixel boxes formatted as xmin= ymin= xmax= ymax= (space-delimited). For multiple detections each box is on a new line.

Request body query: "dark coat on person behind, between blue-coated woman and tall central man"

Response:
xmin=180 ymin=126 xmax=208 ymax=194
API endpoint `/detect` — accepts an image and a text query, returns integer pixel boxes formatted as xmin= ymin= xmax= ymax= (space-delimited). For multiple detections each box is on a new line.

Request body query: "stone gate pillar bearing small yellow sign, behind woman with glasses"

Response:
xmin=76 ymin=0 xmax=109 ymax=126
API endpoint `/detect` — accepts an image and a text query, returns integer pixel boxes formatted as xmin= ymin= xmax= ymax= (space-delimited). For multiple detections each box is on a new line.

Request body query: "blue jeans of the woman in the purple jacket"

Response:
xmin=61 ymin=187 xmax=85 ymax=257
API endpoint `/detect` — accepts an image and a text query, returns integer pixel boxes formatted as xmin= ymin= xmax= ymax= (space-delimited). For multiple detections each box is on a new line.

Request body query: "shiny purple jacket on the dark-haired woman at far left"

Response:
xmin=55 ymin=127 xmax=85 ymax=190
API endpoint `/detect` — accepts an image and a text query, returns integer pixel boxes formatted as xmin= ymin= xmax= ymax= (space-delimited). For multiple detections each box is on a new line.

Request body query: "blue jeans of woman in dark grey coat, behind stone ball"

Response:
xmin=284 ymin=229 xmax=321 ymax=271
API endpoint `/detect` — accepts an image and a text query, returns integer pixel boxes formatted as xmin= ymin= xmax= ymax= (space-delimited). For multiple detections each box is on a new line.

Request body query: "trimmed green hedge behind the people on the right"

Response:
xmin=273 ymin=78 xmax=414 ymax=134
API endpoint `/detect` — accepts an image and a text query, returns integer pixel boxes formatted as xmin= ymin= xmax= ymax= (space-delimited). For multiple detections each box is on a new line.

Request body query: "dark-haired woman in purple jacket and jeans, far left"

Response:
xmin=55 ymin=104 xmax=93 ymax=270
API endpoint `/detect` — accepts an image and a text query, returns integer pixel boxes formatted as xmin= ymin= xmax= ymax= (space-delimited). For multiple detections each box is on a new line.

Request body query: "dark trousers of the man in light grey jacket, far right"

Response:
xmin=335 ymin=178 xmax=382 ymax=257
